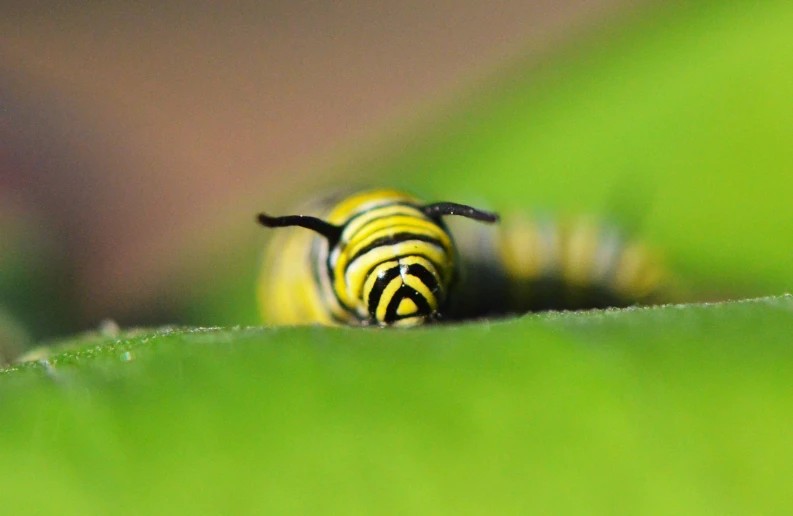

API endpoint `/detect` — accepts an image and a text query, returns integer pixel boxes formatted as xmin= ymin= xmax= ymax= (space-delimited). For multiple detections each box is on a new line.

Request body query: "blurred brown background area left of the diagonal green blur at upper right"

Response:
xmin=0 ymin=0 xmax=628 ymax=332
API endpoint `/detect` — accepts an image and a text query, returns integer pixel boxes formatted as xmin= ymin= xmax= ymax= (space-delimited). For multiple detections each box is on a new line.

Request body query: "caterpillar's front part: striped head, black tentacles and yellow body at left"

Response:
xmin=258 ymin=190 xmax=498 ymax=326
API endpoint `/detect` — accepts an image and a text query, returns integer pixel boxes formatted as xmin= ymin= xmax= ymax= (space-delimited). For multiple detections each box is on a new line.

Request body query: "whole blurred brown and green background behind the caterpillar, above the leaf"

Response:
xmin=0 ymin=0 xmax=793 ymax=344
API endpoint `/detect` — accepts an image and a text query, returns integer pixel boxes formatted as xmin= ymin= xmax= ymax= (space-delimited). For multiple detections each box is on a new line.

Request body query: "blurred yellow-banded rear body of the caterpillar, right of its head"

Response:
xmin=450 ymin=213 xmax=675 ymax=319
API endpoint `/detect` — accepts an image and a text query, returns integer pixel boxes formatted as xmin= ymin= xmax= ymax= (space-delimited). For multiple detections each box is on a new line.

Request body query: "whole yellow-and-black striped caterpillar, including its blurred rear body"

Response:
xmin=257 ymin=189 xmax=671 ymax=326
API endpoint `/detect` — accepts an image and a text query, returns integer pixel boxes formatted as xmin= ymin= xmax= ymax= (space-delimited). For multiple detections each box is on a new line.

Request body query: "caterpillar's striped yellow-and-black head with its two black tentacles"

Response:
xmin=258 ymin=197 xmax=498 ymax=326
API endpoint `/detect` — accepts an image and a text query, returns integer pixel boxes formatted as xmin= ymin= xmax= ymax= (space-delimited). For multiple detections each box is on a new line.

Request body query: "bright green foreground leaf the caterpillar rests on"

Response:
xmin=0 ymin=296 xmax=793 ymax=514
